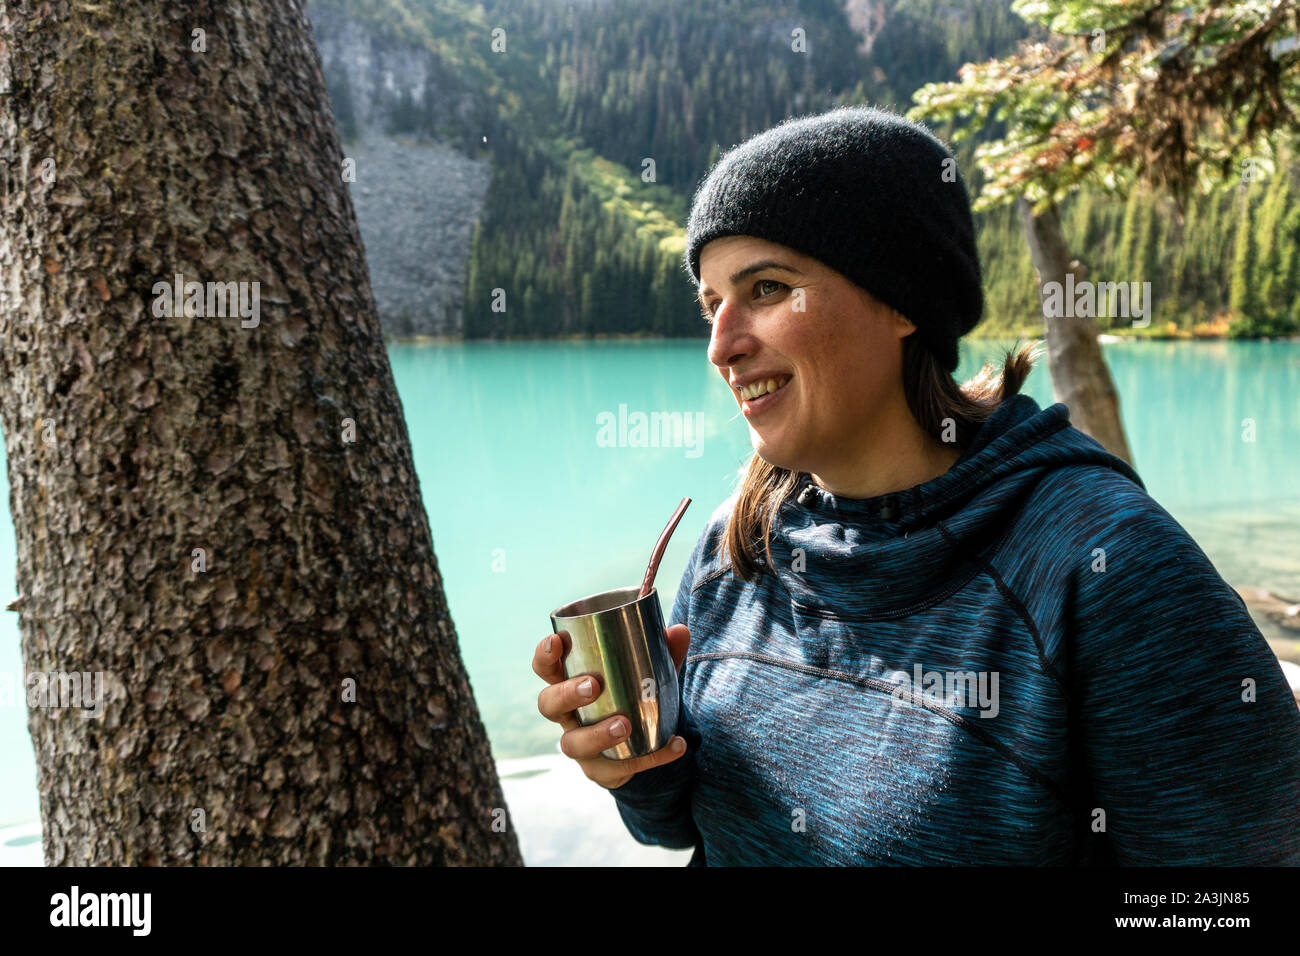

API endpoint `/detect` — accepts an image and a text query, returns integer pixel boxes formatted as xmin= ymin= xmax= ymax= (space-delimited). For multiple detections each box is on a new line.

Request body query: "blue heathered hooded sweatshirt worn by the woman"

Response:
xmin=611 ymin=395 xmax=1300 ymax=866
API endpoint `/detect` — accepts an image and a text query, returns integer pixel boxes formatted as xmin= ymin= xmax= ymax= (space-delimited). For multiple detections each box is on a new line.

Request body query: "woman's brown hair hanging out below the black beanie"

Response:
xmin=719 ymin=333 xmax=1039 ymax=580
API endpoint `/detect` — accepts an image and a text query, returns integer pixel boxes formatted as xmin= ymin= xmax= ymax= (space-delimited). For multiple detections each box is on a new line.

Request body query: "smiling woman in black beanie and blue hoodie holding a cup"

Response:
xmin=533 ymin=108 xmax=1300 ymax=865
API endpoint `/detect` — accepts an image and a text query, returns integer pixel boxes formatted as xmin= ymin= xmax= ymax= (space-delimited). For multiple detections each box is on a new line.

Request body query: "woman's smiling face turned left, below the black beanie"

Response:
xmin=699 ymin=235 xmax=915 ymax=473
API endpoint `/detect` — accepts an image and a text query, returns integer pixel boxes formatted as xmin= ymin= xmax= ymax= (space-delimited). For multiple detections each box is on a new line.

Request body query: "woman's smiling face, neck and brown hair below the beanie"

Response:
xmin=701 ymin=235 xmax=993 ymax=571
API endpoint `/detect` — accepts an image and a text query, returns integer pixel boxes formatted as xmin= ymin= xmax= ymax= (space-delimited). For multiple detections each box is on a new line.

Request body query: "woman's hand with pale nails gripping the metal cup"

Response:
xmin=533 ymin=624 xmax=690 ymax=790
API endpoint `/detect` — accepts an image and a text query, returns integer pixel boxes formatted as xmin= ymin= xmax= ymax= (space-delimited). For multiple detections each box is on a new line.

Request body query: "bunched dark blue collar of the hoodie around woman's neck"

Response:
xmin=771 ymin=395 xmax=1145 ymax=619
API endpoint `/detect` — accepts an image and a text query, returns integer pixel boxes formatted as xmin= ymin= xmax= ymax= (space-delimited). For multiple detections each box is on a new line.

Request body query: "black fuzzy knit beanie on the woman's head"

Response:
xmin=685 ymin=107 xmax=984 ymax=372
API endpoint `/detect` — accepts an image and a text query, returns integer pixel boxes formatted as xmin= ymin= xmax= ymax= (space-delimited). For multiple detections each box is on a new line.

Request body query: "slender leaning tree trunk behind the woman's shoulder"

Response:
xmin=1018 ymin=196 xmax=1132 ymax=464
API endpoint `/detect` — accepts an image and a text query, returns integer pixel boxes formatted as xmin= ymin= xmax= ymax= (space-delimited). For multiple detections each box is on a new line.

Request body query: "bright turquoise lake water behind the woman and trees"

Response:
xmin=0 ymin=339 xmax=1300 ymax=826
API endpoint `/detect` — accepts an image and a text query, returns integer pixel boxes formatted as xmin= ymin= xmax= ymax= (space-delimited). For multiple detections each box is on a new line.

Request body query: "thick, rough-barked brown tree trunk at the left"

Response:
xmin=0 ymin=0 xmax=520 ymax=865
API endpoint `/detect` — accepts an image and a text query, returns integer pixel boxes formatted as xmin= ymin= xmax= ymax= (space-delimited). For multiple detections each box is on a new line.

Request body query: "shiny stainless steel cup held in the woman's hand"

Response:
xmin=551 ymin=585 xmax=681 ymax=760
